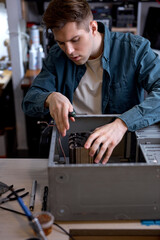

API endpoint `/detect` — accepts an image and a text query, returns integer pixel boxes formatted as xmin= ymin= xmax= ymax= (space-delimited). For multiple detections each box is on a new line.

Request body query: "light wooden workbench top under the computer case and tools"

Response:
xmin=0 ymin=159 xmax=160 ymax=240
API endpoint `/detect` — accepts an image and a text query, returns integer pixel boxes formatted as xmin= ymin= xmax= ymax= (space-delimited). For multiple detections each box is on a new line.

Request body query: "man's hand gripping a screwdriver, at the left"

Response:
xmin=45 ymin=92 xmax=75 ymax=137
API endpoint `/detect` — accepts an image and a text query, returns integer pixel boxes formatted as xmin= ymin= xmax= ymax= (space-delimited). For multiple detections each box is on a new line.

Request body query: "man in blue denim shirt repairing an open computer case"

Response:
xmin=23 ymin=0 xmax=160 ymax=164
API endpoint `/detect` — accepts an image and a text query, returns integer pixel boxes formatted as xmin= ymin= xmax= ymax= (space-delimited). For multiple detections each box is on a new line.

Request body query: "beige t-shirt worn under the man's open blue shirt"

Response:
xmin=73 ymin=55 xmax=103 ymax=114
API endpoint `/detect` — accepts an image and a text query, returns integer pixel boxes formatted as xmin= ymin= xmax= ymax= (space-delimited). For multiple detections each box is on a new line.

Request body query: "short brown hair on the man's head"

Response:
xmin=43 ymin=0 xmax=93 ymax=30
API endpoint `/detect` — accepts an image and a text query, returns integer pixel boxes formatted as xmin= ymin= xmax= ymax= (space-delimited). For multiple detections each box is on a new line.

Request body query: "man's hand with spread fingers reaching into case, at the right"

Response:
xmin=84 ymin=118 xmax=127 ymax=164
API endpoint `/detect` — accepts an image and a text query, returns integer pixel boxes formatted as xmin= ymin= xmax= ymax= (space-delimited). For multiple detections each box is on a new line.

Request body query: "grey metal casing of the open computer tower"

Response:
xmin=48 ymin=115 xmax=160 ymax=221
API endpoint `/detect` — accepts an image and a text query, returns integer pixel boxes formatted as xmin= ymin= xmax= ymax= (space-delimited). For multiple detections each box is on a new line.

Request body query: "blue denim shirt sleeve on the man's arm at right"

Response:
xmin=120 ymin=40 xmax=160 ymax=131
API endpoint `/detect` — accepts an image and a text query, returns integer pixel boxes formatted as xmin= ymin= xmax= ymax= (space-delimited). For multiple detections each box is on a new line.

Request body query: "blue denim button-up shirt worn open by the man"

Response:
xmin=22 ymin=25 xmax=160 ymax=131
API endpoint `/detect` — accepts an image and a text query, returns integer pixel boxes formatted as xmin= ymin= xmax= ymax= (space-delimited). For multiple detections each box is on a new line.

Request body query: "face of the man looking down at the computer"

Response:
xmin=53 ymin=22 xmax=94 ymax=65
